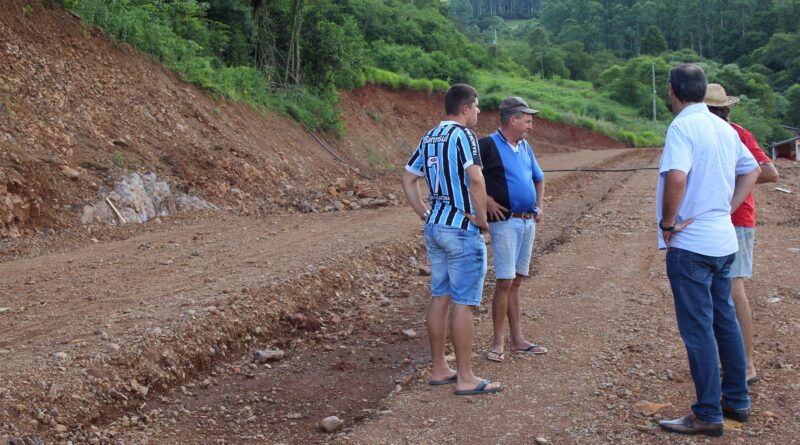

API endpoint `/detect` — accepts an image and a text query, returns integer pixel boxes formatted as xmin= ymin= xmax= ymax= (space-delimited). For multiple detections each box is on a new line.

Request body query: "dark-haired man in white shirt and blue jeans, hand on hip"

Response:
xmin=656 ymin=64 xmax=760 ymax=436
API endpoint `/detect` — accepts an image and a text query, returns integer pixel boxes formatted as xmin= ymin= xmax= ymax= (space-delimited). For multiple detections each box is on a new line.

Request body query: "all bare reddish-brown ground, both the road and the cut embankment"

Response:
xmin=0 ymin=0 xmax=800 ymax=445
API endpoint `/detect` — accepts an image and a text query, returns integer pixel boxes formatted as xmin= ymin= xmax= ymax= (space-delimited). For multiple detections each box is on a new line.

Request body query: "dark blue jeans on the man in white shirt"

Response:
xmin=667 ymin=248 xmax=750 ymax=422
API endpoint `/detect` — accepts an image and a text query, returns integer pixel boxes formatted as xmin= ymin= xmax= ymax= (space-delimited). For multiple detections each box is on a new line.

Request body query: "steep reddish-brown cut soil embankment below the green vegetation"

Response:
xmin=0 ymin=0 xmax=624 ymax=241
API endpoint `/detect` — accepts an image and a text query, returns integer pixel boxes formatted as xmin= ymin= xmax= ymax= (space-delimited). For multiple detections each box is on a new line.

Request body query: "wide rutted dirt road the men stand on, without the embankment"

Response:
xmin=0 ymin=150 xmax=800 ymax=444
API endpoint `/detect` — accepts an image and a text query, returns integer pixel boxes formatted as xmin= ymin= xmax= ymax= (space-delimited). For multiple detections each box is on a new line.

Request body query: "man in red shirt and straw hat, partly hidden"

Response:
xmin=704 ymin=83 xmax=778 ymax=385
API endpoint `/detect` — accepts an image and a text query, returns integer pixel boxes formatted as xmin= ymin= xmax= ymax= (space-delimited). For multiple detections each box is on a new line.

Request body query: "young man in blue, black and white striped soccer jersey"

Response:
xmin=402 ymin=84 xmax=503 ymax=395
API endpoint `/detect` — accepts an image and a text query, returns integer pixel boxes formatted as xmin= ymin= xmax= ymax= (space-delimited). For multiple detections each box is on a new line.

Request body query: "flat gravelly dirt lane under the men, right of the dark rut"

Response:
xmin=350 ymin=151 xmax=800 ymax=444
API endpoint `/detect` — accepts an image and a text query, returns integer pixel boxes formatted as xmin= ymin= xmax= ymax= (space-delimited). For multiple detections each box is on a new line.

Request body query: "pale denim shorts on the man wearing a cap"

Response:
xmin=489 ymin=218 xmax=536 ymax=280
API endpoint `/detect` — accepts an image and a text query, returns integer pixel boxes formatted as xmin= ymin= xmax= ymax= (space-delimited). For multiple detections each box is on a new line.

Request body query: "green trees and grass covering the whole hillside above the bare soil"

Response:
xmin=48 ymin=0 xmax=800 ymax=145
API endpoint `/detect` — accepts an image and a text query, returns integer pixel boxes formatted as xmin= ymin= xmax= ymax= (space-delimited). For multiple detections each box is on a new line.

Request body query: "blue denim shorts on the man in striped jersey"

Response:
xmin=425 ymin=224 xmax=487 ymax=306
